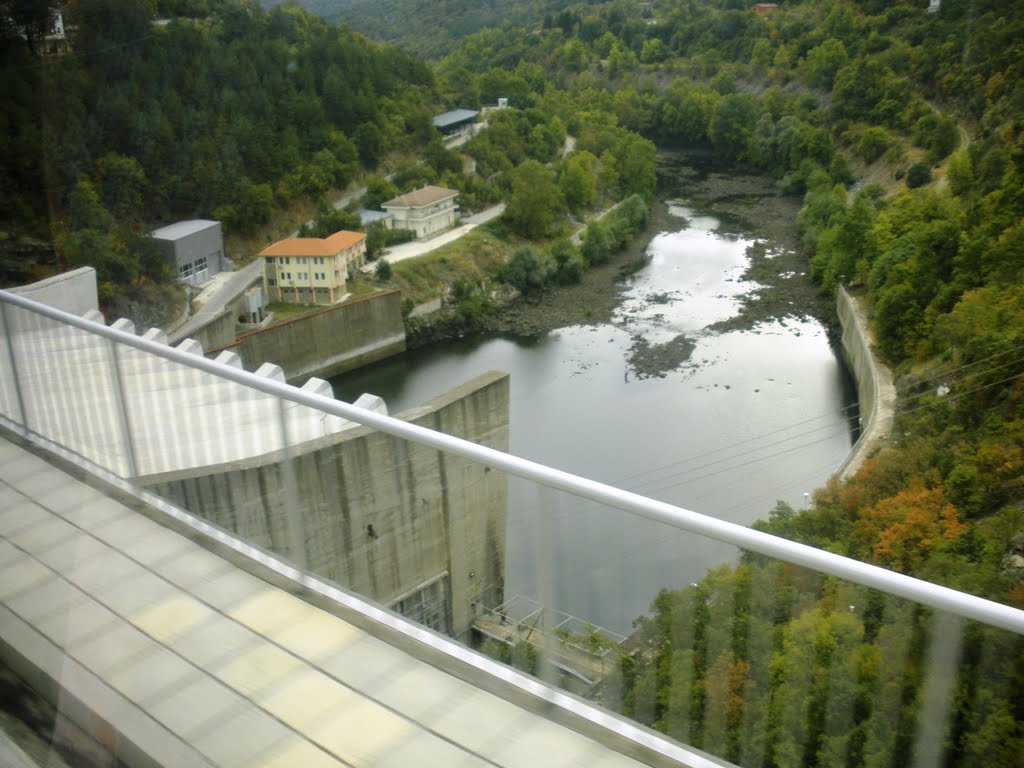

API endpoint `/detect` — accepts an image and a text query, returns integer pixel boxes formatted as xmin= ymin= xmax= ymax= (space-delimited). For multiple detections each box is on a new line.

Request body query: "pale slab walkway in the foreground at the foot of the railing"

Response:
xmin=0 ymin=439 xmax=713 ymax=766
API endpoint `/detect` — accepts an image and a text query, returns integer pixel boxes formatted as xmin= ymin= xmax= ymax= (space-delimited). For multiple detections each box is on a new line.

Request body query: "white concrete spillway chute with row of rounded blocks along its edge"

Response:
xmin=0 ymin=294 xmax=387 ymax=477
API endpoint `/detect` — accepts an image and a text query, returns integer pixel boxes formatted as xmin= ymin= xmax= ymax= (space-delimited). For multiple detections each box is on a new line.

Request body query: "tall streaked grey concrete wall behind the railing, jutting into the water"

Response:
xmin=145 ymin=372 xmax=509 ymax=635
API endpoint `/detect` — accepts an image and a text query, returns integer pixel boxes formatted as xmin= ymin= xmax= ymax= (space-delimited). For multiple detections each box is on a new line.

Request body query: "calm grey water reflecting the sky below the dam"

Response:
xmin=332 ymin=189 xmax=855 ymax=635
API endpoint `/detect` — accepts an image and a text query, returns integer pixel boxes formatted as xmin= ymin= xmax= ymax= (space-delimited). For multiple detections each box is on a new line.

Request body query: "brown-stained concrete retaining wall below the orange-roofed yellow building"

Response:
xmin=209 ymin=291 xmax=406 ymax=382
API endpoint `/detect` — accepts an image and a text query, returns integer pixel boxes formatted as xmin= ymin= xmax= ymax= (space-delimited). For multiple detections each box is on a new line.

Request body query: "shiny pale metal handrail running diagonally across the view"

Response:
xmin=6 ymin=291 xmax=1024 ymax=635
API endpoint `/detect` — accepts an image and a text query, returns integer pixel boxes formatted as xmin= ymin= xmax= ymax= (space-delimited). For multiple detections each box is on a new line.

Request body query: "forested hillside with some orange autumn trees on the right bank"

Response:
xmin=425 ymin=0 xmax=1024 ymax=766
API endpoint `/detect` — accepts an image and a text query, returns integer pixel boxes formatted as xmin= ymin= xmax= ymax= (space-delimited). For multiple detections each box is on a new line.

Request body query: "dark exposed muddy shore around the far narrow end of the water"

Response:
xmin=407 ymin=153 xmax=838 ymax=377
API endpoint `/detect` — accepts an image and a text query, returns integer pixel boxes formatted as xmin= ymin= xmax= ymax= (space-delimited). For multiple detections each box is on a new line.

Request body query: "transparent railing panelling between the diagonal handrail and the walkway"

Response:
xmin=0 ymin=292 xmax=1024 ymax=766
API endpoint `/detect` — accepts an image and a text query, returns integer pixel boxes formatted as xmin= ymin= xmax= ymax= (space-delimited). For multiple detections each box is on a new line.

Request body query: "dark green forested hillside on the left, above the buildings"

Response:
xmin=0 ymin=0 xmax=437 ymax=309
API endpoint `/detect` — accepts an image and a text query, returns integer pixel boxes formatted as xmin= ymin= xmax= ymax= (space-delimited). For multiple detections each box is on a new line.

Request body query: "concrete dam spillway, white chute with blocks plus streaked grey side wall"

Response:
xmin=0 ymin=269 xmax=509 ymax=636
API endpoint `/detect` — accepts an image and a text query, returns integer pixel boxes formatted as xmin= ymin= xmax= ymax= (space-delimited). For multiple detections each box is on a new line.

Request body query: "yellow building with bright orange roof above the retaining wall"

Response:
xmin=259 ymin=229 xmax=367 ymax=304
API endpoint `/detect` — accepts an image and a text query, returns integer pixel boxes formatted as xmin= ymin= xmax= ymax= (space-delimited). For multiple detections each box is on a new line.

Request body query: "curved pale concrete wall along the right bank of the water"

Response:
xmin=836 ymin=286 xmax=896 ymax=480
